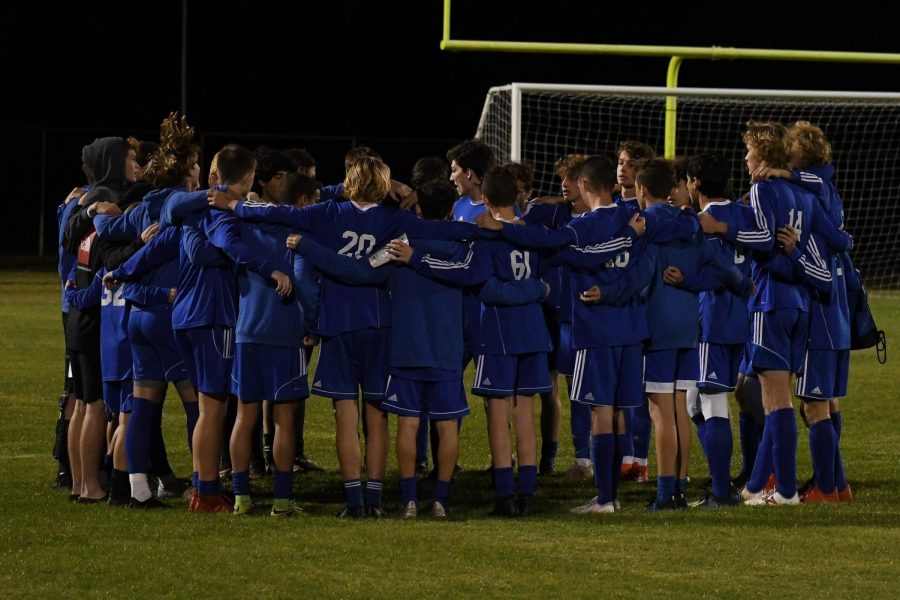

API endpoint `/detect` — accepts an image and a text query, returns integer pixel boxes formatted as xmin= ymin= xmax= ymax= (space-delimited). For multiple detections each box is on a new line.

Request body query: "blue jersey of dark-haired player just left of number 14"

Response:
xmin=700 ymin=200 xmax=752 ymax=344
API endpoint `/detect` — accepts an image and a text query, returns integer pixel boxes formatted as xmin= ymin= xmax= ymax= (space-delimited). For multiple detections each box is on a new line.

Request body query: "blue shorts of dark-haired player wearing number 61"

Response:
xmin=472 ymin=352 xmax=553 ymax=398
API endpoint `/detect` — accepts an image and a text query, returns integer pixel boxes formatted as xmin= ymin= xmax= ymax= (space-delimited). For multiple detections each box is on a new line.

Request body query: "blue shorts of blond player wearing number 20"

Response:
xmin=312 ymin=329 xmax=391 ymax=404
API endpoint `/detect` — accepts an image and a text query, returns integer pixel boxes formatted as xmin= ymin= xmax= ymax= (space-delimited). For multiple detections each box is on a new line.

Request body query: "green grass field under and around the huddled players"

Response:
xmin=0 ymin=271 xmax=900 ymax=598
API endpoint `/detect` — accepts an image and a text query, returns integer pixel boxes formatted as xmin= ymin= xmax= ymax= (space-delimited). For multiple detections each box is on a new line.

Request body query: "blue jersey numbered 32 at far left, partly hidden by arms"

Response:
xmin=66 ymin=269 xmax=132 ymax=381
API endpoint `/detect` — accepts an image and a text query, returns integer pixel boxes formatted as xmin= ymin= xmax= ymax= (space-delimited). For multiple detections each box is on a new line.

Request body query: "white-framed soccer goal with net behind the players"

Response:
xmin=476 ymin=83 xmax=900 ymax=290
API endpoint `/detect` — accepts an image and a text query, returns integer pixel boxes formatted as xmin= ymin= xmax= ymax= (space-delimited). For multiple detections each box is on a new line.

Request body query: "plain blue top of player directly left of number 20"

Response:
xmin=235 ymin=223 xmax=303 ymax=347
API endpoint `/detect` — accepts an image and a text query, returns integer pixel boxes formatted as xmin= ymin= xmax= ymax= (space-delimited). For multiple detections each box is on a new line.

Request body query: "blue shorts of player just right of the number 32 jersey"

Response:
xmin=128 ymin=310 xmax=188 ymax=381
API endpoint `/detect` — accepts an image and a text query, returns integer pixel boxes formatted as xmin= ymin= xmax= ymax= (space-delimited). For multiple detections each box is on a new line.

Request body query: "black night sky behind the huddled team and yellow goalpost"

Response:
xmin=0 ymin=0 xmax=900 ymax=260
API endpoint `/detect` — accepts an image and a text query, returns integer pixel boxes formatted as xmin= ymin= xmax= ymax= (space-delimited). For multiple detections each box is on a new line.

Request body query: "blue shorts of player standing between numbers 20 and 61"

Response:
xmin=381 ymin=371 xmax=469 ymax=421
